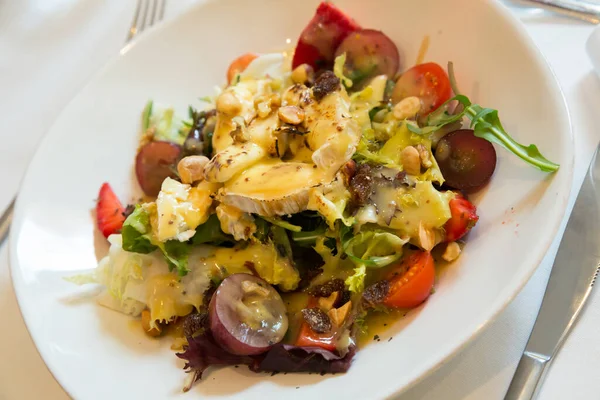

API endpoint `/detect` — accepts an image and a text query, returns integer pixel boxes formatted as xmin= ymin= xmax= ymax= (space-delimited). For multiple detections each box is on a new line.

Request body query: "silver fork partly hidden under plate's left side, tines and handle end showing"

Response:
xmin=0 ymin=0 xmax=167 ymax=245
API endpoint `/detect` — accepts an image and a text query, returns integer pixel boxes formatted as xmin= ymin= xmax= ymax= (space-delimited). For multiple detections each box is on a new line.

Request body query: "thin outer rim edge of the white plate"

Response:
xmin=8 ymin=0 xmax=575 ymax=398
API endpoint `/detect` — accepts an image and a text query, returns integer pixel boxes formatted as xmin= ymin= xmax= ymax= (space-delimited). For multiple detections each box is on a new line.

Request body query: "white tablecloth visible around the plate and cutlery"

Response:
xmin=0 ymin=0 xmax=600 ymax=400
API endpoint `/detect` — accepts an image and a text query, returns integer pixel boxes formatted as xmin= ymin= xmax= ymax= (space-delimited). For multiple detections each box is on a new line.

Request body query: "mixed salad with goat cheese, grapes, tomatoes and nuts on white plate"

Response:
xmin=83 ymin=2 xmax=558 ymax=390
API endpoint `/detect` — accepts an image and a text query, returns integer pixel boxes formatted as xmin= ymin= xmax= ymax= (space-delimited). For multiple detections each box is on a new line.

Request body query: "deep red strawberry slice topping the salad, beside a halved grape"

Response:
xmin=292 ymin=1 xmax=361 ymax=70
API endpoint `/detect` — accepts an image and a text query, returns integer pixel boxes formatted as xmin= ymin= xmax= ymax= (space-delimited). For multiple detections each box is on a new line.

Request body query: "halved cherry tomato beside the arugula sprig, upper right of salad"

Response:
xmin=392 ymin=63 xmax=452 ymax=115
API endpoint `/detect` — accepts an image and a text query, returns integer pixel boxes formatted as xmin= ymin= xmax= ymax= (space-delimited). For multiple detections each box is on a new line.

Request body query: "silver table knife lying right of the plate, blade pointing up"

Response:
xmin=504 ymin=145 xmax=600 ymax=400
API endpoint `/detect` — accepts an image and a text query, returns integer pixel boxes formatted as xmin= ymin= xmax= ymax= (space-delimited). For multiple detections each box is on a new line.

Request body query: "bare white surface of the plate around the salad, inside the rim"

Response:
xmin=10 ymin=0 xmax=573 ymax=400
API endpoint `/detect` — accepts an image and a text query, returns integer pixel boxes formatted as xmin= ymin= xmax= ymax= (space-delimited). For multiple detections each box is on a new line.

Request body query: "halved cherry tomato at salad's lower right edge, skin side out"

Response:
xmin=383 ymin=251 xmax=435 ymax=308
